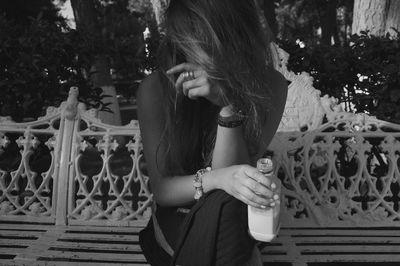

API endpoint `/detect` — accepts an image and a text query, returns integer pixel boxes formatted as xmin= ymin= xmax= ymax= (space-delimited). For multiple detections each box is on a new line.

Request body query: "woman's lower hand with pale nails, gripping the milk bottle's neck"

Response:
xmin=211 ymin=165 xmax=279 ymax=209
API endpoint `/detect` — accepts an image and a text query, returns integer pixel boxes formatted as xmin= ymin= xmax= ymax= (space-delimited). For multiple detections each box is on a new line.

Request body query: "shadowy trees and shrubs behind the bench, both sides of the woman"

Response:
xmin=0 ymin=0 xmax=400 ymax=124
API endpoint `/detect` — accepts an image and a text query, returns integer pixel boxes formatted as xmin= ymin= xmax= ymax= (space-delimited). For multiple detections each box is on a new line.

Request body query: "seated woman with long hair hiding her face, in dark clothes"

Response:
xmin=137 ymin=0 xmax=287 ymax=265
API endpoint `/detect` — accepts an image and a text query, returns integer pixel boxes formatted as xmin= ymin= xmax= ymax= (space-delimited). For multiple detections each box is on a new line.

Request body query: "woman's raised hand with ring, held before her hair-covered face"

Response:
xmin=167 ymin=63 xmax=227 ymax=107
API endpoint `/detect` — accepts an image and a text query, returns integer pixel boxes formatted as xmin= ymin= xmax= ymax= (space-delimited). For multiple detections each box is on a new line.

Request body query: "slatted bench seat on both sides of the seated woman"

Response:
xmin=0 ymin=223 xmax=400 ymax=266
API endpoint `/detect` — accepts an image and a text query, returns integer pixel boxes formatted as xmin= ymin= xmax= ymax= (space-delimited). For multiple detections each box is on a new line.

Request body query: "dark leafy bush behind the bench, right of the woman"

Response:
xmin=280 ymin=31 xmax=400 ymax=123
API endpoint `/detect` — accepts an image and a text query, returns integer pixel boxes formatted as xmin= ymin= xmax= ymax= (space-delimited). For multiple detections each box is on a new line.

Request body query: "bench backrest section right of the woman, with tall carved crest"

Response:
xmin=269 ymin=45 xmax=400 ymax=227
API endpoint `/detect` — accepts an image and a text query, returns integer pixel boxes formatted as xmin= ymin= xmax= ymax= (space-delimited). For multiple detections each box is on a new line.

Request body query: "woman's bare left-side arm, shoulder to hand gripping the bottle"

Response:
xmin=137 ymin=73 xmax=272 ymax=207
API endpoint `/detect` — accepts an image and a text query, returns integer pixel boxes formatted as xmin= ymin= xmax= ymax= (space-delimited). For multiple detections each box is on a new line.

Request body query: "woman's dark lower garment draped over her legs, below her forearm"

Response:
xmin=140 ymin=190 xmax=255 ymax=266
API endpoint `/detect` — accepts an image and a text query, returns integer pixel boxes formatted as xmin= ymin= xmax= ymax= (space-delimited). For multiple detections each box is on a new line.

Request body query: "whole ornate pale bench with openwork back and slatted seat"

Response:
xmin=0 ymin=46 xmax=400 ymax=266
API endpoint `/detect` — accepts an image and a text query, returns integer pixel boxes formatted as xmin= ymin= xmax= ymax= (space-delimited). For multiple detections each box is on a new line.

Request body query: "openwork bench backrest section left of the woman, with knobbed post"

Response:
xmin=0 ymin=88 xmax=152 ymax=226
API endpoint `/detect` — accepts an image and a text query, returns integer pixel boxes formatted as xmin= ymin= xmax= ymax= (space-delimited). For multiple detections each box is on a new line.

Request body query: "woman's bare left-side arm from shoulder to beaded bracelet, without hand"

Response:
xmin=137 ymin=73 xmax=205 ymax=206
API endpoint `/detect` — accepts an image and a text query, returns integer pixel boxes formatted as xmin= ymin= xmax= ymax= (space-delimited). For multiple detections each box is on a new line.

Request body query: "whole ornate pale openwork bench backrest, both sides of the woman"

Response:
xmin=0 ymin=46 xmax=400 ymax=227
